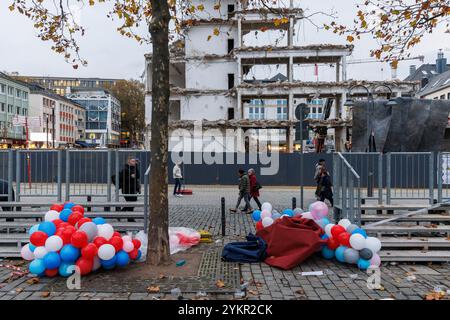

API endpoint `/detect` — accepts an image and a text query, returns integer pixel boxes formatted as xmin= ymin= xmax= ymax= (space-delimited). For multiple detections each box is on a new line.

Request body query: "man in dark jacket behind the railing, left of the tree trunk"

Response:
xmin=119 ymin=157 xmax=141 ymax=215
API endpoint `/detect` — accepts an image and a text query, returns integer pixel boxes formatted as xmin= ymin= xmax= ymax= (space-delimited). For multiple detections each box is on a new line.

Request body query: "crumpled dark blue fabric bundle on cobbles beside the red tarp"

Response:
xmin=222 ymin=233 xmax=267 ymax=263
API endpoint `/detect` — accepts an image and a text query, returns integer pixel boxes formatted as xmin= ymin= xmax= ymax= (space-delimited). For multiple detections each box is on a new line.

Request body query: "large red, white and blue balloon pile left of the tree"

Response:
xmin=21 ymin=202 xmax=142 ymax=277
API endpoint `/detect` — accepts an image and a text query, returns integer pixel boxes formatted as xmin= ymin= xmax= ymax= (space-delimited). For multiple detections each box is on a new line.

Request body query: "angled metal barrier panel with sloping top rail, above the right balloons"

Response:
xmin=333 ymin=152 xmax=361 ymax=225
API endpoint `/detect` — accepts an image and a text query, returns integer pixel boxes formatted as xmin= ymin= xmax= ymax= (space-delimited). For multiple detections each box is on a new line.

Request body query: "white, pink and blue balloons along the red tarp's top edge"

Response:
xmin=252 ymin=201 xmax=330 ymax=231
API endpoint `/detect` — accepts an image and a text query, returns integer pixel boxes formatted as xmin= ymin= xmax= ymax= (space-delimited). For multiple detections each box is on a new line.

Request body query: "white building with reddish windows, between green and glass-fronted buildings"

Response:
xmin=28 ymin=84 xmax=86 ymax=148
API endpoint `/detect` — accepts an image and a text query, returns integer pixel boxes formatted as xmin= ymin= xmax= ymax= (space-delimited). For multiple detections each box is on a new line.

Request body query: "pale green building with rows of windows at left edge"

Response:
xmin=0 ymin=72 xmax=30 ymax=148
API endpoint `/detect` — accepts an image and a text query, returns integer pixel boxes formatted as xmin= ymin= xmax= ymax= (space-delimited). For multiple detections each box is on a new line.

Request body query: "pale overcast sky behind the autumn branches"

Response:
xmin=0 ymin=0 xmax=450 ymax=80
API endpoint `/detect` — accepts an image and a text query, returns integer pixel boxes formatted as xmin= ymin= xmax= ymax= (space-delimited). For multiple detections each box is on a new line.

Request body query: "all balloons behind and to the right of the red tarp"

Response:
xmin=252 ymin=201 xmax=381 ymax=270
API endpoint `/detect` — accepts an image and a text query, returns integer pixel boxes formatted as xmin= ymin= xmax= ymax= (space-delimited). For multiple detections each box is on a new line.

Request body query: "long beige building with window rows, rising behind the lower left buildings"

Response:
xmin=16 ymin=75 xmax=120 ymax=96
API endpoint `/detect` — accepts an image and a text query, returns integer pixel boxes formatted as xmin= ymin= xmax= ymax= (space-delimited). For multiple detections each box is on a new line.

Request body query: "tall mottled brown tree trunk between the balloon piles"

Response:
xmin=147 ymin=0 xmax=170 ymax=265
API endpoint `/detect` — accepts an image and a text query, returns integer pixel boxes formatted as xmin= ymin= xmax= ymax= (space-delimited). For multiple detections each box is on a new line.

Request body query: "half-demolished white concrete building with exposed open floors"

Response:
xmin=146 ymin=0 xmax=416 ymax=152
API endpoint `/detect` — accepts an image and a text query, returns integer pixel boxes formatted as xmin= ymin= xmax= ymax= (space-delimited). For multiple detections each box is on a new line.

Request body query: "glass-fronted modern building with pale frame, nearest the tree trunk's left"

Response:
xmin=67 ymin=88 xmax=121 ymax=147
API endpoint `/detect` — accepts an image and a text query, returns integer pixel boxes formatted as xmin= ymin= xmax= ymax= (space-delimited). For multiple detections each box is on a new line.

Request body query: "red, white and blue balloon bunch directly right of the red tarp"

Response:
xmin=322 ymin=219 xmax=381 ymax=270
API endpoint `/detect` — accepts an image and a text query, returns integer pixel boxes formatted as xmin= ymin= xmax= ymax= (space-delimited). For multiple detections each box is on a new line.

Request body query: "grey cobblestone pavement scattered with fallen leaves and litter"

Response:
xmin=0 ymin=188 xmax=450 ymax=300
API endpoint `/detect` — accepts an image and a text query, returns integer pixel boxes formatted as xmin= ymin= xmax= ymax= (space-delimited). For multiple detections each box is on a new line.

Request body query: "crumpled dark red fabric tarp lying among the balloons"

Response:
xmin=256 ymin=217 xmax=326 ymax=270
